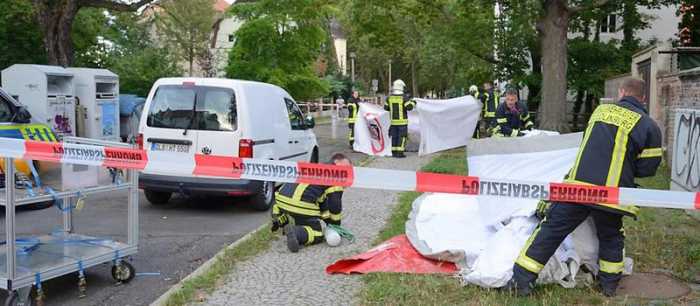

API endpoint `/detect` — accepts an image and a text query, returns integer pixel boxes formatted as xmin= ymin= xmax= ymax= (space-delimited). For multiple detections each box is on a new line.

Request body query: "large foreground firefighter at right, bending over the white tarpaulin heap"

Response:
xmin=504 ymin=78 xmax=662 ymax=296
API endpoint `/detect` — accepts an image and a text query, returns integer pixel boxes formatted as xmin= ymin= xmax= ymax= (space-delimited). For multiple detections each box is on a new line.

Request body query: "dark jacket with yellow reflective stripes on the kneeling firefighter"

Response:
xmin=273 ymin=183 xmax=343 ymax=225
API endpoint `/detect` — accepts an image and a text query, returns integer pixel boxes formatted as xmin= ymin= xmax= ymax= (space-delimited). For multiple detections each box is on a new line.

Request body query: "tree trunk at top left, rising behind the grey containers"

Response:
xmin=32 ymin=0 xmax=78 ymax=67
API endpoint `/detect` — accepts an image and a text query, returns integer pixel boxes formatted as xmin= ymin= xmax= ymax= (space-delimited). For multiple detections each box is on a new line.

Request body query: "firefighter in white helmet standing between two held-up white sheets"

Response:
xmin=384 ymin=80 xmax=416 ymax=158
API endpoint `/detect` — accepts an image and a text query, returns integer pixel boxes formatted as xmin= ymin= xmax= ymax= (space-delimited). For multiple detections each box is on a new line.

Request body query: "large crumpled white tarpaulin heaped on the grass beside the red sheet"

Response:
xmin=406 ymin=134 xmax=632 ymax=288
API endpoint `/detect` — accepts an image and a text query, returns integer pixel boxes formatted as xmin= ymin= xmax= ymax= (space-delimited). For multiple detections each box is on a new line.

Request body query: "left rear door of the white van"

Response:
xmin=142 ymin=82 xmax=198 ymax=174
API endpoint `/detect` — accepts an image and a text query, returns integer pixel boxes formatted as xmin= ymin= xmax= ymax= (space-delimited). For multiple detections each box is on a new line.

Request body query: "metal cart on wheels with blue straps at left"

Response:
xmin=0 ymin=137 xmax=138 ymax=305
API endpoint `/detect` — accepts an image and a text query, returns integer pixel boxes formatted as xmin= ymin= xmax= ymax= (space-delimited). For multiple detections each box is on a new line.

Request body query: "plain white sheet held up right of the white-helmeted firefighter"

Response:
xmin=415 ymin=96 xmax=482 ymax=155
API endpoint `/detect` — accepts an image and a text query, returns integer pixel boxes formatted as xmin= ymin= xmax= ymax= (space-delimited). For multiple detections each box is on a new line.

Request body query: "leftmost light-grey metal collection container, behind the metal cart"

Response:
xmin=2 ymin=64 xmax=75 ymax=141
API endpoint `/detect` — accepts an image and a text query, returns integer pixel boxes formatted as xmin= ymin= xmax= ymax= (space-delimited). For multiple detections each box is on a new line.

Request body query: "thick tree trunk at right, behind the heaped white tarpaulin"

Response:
xmin=537 ymin=0 xmax=571 ymax=133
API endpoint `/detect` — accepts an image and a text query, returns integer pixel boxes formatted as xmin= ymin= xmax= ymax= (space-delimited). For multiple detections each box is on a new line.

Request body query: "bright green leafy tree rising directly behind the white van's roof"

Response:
xmin=226 ymin=0 xmax=332 ymax=100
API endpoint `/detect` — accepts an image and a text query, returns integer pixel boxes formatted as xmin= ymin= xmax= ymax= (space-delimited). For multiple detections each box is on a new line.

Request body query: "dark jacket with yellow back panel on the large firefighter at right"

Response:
xmin=565 ymin=96 xmax=663 ymax=216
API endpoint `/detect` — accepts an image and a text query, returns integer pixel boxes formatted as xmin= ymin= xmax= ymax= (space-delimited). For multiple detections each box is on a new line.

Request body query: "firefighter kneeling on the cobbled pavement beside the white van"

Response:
xmin=271 ymin=153 xmax=351 ymax=253
